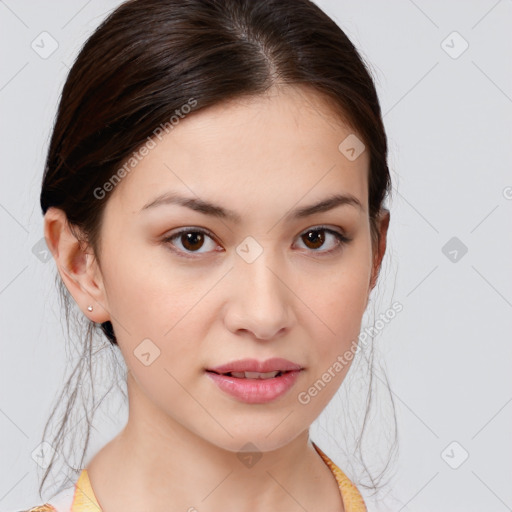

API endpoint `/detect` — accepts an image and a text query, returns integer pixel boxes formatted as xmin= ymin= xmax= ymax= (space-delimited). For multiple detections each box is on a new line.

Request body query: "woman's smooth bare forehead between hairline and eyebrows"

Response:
xmin=108 ymin=87 xmax=369 ymax=217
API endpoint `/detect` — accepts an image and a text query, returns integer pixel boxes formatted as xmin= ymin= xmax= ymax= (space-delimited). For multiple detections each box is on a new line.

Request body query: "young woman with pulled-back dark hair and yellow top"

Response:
xmin=24 ymin=0 xmax=390 ymax=512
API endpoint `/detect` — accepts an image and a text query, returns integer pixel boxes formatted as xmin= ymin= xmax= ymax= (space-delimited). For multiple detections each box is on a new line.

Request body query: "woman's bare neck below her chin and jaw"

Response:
xmin=87 ymin=374 xmax=343 ymax=512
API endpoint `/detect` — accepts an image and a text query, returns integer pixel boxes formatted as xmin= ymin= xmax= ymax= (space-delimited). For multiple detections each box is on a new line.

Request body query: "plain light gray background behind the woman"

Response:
xmin=0 ymin=0 xmax=512 ymax=512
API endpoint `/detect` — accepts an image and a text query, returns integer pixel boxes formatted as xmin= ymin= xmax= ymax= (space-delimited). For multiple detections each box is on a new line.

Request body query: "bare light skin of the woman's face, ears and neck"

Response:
xmin=44 ymin=87 xmax=389 ymax=512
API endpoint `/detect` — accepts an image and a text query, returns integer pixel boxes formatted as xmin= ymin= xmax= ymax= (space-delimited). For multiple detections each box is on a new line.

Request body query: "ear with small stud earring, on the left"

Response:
xmin=44 ymin=207 xmax=110 ymax=323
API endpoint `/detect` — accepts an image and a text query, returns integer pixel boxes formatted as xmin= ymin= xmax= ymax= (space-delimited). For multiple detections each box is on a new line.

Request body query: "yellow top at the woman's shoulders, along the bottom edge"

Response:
xmin=27 ymin=443 xmax=367 ymax=512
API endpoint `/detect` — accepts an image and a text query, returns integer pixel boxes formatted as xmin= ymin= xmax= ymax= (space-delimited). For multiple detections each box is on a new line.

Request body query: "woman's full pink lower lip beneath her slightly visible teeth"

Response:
xmin=206 ymin=370 xmax=301 ymax=404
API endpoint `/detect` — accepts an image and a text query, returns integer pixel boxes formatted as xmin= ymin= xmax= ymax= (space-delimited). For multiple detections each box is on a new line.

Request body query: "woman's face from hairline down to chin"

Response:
xmin=87 ymin=89 xmax=384 ymax=451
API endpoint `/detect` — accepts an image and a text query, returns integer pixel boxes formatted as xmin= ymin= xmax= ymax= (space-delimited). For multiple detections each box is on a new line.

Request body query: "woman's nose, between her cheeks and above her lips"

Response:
xmin=225 ymin=250 xmax=293 ymax=339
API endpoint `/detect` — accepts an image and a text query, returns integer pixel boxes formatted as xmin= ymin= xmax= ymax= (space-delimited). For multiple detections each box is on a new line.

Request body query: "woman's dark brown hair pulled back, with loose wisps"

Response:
xmin=40 ymin=0 xmax=391 ymax=500
